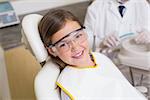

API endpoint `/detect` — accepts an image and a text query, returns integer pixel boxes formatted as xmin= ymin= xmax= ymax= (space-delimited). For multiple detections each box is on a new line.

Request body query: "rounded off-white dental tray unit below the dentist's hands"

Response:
xmin=118 ymin=38 xmax=150 ymax=70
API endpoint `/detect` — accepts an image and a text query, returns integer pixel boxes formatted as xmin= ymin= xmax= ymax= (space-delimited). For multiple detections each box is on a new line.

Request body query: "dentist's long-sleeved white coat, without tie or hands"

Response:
xmin=84 ymin=0 xmax=150 ymax=47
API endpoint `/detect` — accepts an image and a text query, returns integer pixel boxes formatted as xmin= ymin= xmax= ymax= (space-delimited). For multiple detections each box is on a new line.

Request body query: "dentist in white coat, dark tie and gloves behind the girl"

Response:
xmin=84 ymin=0 xmax=150 ymax=51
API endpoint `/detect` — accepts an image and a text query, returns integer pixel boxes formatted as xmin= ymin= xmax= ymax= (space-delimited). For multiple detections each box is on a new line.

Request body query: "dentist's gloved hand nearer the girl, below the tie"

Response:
xmin=102 ymin=33 xmax=120 ymax=48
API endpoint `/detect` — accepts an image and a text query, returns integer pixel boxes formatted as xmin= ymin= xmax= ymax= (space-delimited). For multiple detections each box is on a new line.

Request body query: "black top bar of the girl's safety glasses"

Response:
xmin=48 ymin=26 xmax=85 ymax=48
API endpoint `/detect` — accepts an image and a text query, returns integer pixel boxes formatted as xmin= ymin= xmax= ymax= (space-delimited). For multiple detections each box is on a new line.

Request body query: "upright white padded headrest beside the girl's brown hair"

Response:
xmin=22 ymin=14 xmax=48 ymax=62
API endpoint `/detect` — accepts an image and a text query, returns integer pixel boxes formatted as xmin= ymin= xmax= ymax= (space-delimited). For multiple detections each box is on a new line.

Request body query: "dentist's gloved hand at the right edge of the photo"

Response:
xmin=134 ymin=30 xmax=150 ymax=44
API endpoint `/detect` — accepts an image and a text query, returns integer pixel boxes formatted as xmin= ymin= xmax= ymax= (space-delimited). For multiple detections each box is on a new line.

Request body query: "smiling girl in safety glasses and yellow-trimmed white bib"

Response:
xmin=39 ymin=10 xmax=146 ymax=100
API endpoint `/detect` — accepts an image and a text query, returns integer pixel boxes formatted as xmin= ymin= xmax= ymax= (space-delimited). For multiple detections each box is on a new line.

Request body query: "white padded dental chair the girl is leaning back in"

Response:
xmin=21 ymin=14 xmax=60 ymax=100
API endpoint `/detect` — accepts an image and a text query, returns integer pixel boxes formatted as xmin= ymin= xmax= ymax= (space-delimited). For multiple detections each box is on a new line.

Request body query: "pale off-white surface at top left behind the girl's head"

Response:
xmin=11 ymin=0 xmax=89 ymax=15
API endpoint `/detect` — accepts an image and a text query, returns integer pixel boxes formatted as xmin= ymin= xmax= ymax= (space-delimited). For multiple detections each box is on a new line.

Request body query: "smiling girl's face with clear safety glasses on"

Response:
xmin=49 ymin=20 xmax=91 ymax=66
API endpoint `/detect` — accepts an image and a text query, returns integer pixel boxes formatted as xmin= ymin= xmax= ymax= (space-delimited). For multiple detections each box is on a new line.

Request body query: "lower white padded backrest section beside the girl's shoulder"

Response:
xmin=34 ymin=61 xmax=60 ymax=100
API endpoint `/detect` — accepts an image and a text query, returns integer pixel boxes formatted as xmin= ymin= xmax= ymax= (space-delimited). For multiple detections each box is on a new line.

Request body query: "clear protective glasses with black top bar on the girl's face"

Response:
xmin=48 ymin=27 xmax=87 ymax=52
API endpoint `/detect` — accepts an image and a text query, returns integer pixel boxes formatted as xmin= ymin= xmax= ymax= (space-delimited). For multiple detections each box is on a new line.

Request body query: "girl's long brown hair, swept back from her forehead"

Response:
xmin=38 ymin=9 xmax=82 ymax=67
